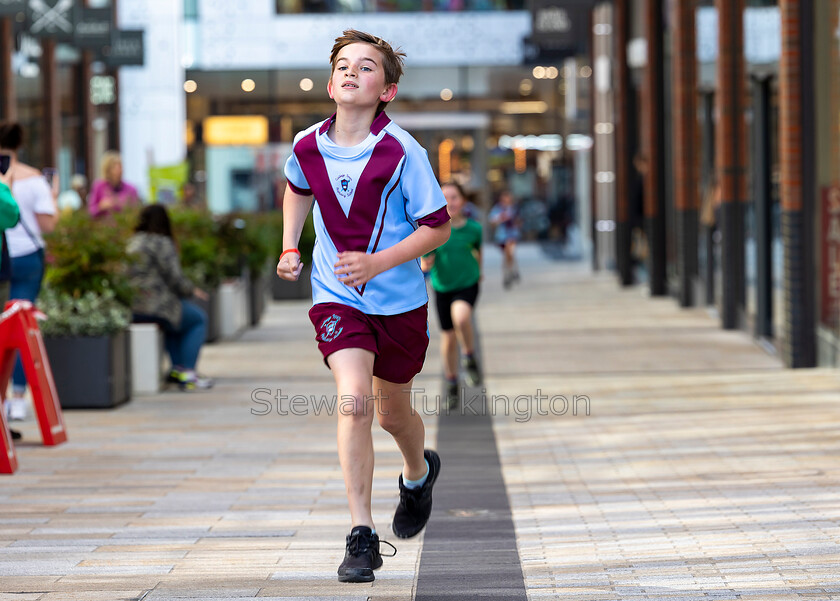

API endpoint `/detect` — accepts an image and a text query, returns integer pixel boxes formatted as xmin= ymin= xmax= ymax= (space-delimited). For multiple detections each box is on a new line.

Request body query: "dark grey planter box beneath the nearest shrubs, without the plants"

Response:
xmin=44 ymin=331 xmax=131 ymax=409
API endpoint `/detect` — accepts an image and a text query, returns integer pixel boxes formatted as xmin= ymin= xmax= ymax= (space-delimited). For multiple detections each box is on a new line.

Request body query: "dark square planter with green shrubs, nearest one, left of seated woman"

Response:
xmin=38 ymin=211 xmax=136 ymax=408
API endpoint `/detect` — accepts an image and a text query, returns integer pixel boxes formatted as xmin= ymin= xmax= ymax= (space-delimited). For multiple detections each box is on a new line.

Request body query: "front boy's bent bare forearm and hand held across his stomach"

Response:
xmin=335 ymin=221 xmax=451 ymax=286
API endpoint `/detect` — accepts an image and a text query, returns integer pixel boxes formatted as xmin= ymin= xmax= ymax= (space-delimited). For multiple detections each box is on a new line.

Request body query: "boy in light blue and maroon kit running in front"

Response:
xmin=277 ymin=30 xmax=449 ymax=582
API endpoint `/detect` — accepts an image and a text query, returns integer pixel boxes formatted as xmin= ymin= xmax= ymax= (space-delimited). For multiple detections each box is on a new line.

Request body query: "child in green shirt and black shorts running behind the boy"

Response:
xmin=423 ymin=182 xmax=481 ymax=408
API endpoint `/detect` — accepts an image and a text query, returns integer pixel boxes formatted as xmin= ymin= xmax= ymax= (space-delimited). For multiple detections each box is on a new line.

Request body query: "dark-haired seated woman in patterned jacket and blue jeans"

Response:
xmin=128 ymin=204 xmax=213 ymax=390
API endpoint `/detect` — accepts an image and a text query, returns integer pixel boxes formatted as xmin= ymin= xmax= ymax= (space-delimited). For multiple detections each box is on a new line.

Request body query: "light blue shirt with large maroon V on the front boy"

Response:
xmin=285 ymin=112 xmax=449 ymax=315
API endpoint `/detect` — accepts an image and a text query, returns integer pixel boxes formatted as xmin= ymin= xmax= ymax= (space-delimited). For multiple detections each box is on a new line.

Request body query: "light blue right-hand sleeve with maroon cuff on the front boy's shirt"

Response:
xmin=400 ymin=140 xmax=449 ymax=227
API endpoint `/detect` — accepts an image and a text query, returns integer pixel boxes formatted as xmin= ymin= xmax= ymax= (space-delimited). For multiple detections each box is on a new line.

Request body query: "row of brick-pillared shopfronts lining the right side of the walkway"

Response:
xmin=595 ymin=0 xmax=824 ymax=367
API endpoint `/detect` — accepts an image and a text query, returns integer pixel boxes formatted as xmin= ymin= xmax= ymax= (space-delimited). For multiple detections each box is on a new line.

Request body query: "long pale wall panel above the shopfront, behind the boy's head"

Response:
xmin=195 ymin=6 xmax=531 ymax=70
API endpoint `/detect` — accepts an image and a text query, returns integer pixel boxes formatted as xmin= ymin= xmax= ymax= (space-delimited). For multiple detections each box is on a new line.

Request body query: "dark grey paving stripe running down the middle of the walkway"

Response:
xmin=415 ymin=390 xmax=528 ymax=601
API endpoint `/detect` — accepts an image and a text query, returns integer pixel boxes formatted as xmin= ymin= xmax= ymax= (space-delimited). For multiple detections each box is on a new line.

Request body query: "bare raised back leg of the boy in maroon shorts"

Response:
xmin=373 ymin=378 xmax=426 ymax=480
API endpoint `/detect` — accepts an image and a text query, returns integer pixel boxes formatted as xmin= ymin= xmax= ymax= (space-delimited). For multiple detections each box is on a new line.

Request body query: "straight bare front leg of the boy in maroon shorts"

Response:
xmin=327 ymin=348 xmax=378 ymax=529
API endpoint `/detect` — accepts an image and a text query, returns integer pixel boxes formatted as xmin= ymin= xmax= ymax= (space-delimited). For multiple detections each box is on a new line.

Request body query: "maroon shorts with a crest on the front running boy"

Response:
xmin=309 ymin=303 xmax=429 ymax=384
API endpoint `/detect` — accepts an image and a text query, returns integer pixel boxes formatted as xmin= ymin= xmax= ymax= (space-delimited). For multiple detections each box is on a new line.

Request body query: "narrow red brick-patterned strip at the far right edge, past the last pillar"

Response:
xmin=820 ymin=186 xmax=840 ymax=329
